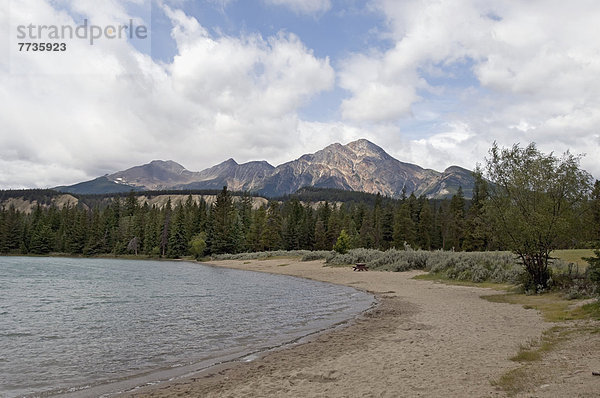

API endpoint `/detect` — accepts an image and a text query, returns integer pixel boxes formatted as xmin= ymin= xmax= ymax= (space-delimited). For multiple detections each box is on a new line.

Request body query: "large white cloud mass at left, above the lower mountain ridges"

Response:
xmin=0 ymin=0 xmax=334 ymax=187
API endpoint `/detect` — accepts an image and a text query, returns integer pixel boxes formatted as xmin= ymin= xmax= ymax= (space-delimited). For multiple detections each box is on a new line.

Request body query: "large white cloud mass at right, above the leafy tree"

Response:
xmin=339 ymin=0 xmax=600 ymax=177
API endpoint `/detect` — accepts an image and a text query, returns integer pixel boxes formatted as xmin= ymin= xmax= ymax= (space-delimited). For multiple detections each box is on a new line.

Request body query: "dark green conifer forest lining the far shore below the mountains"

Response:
xmin=0 ymin=179 xmax=600 ymax=258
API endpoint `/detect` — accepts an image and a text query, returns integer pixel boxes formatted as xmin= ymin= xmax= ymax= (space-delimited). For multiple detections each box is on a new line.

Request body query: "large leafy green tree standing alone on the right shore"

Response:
xmin=486 ymin=143 xmax=592 ymax=291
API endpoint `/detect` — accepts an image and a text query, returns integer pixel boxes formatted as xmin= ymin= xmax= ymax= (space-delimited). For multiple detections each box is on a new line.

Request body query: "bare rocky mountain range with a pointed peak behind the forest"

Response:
xmin=59 ymin=139 xmax=473 ymax=198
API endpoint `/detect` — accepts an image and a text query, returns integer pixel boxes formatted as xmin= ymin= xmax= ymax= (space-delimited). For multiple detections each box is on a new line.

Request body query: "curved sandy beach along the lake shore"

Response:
xmin=120 ymin=259 xmax=600 ymax=397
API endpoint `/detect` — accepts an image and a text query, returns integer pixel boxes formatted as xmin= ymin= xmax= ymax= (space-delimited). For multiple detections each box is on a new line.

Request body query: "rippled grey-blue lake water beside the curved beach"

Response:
xmin=0 ymin=257 xmax=373 ymax=397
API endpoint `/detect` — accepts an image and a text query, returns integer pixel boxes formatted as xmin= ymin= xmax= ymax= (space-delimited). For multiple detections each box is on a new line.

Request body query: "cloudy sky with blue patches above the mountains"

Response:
xmin=0 ymin=0 xmax=600 ymax=189
